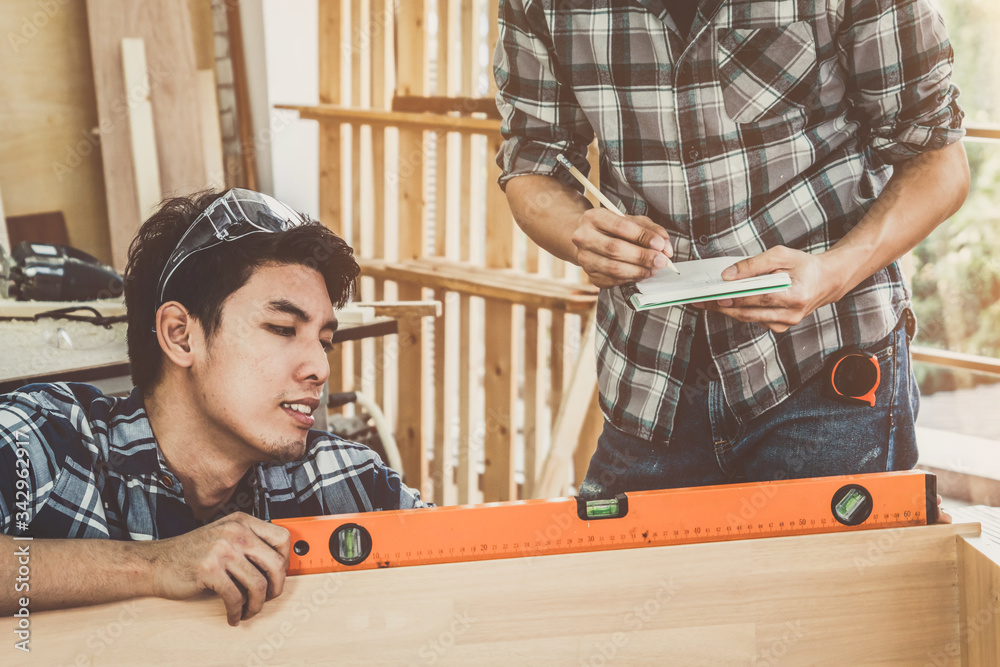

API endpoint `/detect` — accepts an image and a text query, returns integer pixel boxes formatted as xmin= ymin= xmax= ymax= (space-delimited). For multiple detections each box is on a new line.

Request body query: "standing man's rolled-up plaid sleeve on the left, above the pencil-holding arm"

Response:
xmin=493 ymin=0 xmax=594 ymax=191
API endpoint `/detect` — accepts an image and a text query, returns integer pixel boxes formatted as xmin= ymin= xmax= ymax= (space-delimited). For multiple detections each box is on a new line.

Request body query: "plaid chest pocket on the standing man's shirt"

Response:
xmin=718 ymin=21 xmax=819 ymax=123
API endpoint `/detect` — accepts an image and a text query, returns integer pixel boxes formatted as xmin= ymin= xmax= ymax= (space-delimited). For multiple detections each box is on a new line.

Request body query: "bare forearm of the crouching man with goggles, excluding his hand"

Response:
xmin=0 ymin=535 xmax=154 ymax=615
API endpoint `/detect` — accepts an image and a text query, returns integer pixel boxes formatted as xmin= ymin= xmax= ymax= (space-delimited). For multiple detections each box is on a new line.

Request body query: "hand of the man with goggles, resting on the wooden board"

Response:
xmin=150 ymin=513 xmax=291 ymax=625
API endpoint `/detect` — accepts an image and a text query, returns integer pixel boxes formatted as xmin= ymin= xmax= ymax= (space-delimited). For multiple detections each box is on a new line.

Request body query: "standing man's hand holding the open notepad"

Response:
xmin=693 ymin=246 xmax=843 ymax=333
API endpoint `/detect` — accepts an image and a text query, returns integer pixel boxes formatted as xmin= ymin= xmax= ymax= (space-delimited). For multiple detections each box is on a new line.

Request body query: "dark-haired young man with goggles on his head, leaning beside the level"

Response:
xmin=0 ymin=189 xmax=423 ymax=625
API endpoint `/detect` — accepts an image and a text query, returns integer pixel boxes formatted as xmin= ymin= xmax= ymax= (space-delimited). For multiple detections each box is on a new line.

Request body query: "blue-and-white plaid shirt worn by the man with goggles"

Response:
xmin=0 ymin=383 xmax=423 ymax=540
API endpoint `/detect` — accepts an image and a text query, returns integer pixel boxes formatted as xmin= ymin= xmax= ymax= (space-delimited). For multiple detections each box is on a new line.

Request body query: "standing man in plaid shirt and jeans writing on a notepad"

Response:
xmin=495 ymin=0 xmax=969 ymax=496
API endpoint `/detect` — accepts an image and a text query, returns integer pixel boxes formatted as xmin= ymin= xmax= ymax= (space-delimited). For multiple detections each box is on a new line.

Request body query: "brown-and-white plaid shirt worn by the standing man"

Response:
xmin=494 ymin=0 xmax=964 ymax=441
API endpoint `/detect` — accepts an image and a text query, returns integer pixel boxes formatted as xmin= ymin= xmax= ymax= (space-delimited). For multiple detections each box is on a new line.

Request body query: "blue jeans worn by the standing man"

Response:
xmin=580 ymin=314 xmax=920 ymax=498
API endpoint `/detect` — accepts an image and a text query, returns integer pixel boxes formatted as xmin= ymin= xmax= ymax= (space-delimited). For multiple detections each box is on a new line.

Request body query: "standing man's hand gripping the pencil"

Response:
xmin=572 ymin=208 xmax=674 ymax=287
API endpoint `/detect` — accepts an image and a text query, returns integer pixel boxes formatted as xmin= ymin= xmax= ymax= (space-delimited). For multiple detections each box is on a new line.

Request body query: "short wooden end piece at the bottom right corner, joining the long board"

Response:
xmin=952 ymin=536 xmax=1000 ymax=665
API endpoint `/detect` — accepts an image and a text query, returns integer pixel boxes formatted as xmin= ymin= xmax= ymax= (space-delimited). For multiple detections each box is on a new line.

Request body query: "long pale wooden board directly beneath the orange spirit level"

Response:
xmin=0 ymin=524 xmax=976 ymax=667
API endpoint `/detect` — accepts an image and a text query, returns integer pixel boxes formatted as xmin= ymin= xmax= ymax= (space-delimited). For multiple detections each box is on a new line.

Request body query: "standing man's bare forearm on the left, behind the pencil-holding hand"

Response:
xmin=506 ymin=174 xmax=591 ymax=263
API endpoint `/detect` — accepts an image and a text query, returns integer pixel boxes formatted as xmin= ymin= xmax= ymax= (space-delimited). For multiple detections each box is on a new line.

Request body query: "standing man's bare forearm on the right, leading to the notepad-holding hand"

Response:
xmin=822 ymin=142 xmax=969 ymax=298
